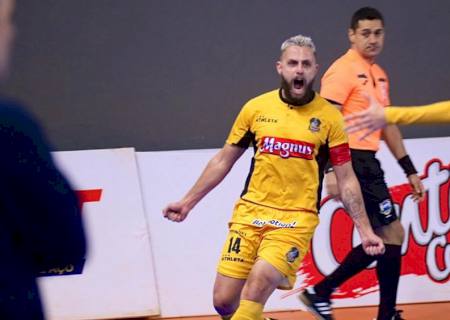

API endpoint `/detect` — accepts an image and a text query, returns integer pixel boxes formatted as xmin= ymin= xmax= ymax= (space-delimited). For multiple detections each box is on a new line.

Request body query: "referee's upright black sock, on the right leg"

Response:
xmin=377 ymin=244 xmax=402 ymax=319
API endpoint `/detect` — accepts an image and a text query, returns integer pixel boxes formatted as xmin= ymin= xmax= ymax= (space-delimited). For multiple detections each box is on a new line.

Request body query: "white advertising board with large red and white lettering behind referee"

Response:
xmin=137 ymin=138 xmax=450 ymax=317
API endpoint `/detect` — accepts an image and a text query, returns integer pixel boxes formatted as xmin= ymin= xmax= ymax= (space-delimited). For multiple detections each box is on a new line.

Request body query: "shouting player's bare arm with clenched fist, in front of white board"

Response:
xmin=163 ymin=144 xmax=245 ymax=222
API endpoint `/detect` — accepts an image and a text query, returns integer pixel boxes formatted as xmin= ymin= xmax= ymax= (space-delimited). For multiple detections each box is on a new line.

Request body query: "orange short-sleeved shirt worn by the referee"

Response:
xmin=320 ymin=49 xmax=390 ymax=151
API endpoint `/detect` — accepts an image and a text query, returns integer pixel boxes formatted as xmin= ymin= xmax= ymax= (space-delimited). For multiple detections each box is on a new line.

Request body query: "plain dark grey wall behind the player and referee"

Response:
xmin=3 ymin=0 xmax=450 ymax=151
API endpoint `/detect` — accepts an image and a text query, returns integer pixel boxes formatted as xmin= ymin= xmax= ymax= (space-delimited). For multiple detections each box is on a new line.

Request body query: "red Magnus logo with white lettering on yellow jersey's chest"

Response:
xmin=259 ymin=137 xmax=314 ymax=160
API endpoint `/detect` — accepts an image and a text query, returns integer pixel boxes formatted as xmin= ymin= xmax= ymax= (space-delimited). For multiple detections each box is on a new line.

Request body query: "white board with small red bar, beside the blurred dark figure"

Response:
xmin=39 ymin=148 xmax=159 ymax=320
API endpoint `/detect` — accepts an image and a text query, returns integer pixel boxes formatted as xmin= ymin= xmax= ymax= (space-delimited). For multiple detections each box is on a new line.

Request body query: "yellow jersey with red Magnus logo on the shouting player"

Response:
xmin=226 ymin=90 xmax=350 ymax=213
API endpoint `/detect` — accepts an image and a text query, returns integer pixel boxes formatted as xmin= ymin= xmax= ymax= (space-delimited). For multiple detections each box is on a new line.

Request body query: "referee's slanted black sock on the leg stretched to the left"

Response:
xmin=314 ymin=245 xmax=376 ymax=297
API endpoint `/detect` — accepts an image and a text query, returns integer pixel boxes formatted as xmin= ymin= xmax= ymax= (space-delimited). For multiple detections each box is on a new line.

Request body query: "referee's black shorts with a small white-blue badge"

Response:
xmin=351 ymin=149 xmax=397 ymax=228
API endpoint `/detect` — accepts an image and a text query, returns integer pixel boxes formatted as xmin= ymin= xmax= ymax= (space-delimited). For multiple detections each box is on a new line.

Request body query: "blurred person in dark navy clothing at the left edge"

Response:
xmin=0 ymin=0 xmax=86 ymax=320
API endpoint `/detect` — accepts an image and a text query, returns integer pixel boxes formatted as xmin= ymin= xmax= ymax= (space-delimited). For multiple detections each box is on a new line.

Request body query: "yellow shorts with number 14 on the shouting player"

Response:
xmin=217 ymin=199 xmax=319 ymax=289
